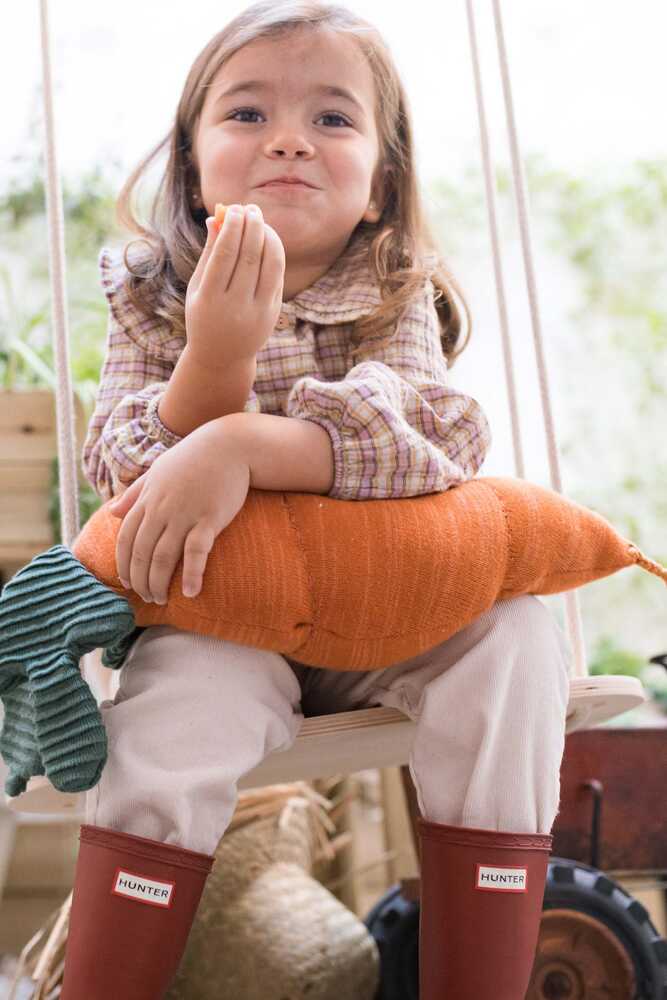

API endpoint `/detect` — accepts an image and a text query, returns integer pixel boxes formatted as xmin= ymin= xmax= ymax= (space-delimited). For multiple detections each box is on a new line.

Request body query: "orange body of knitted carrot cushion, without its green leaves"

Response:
xmin=73 ymin=477 xmax=667 ymax=670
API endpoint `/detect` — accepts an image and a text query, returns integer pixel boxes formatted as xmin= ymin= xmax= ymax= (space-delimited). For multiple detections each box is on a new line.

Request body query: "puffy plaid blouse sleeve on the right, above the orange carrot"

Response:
xmin=286 ymin=280 xmax=491 ymax=500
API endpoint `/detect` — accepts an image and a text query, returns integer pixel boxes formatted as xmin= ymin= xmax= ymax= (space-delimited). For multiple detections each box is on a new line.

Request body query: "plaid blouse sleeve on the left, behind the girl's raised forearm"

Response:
xmin=82 ymin=248 xmax=259 ymax=500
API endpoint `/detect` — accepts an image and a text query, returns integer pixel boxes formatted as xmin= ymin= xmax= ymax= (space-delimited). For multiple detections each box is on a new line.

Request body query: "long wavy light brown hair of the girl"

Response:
xmin=116 ymin=0 xmax=472 ymax=367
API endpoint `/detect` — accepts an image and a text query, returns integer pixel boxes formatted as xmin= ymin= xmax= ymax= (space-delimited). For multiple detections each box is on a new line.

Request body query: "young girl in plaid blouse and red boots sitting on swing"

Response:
xmin=62 ymin=0 xmax=569 ymax=1000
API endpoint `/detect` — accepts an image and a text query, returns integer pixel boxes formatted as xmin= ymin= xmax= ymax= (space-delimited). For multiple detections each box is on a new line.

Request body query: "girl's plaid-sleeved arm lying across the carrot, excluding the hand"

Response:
xmin=198 ymin=280 xmax=490 ymax=500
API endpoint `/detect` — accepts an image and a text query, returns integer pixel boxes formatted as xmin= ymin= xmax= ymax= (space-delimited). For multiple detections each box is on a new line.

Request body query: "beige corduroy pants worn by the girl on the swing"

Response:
xmin=86 ymin=595 xmax=569 ymax=854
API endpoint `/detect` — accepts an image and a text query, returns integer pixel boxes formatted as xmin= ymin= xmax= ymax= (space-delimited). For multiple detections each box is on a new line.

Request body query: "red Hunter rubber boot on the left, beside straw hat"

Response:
xmin=60 ymin=824 xmax=215 ymax=1000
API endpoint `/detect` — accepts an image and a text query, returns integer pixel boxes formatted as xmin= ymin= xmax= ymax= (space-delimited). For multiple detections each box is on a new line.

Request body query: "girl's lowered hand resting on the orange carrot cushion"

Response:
xmin=109 ymin=423 xmax=250 ymax=604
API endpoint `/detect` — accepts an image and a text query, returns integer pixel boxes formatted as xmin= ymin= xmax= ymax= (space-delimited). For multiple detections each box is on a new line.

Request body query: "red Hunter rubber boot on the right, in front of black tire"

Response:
xmin=417 ymin=817 xmax=553 ymax=1000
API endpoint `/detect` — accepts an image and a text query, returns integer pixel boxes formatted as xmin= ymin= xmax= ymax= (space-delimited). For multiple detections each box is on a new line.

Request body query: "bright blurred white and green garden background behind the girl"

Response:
xmin=0 ymin=0 xmax=667 ymax=988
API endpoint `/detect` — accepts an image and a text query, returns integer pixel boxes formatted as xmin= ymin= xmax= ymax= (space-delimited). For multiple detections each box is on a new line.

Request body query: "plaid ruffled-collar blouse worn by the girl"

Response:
xmin=82 ymin=231 xmax=491 ymax=500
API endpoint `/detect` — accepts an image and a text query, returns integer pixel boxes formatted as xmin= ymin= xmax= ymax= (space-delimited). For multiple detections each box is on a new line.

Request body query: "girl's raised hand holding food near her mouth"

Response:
xmin=185 ymin=205 xmax=285 ymax=368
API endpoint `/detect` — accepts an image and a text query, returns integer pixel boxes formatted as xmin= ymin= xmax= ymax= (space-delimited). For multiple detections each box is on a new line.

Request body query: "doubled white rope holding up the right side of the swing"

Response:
xmin=466 ymin=0 xmax=588 ymax=677
